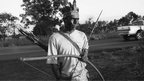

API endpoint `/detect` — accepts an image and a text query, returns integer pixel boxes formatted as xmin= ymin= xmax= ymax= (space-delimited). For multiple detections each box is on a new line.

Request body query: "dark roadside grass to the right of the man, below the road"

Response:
xmin=91 ymin=47 xmax=144 ymax=81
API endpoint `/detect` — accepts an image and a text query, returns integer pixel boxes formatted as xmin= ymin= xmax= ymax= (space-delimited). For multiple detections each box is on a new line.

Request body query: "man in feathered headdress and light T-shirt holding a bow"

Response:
xmin=47 ymin=0 xmax=89 ymax=81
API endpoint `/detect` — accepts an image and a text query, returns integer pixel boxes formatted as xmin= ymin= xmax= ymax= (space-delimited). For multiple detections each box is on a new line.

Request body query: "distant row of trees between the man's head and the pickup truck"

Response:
xmin=79 ymin=12 xmax=144 ymax=34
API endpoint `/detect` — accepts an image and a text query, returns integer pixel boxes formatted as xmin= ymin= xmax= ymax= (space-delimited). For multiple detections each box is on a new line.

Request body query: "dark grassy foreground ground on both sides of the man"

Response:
xmin=0 ymin=47 xmax=144 ymax=81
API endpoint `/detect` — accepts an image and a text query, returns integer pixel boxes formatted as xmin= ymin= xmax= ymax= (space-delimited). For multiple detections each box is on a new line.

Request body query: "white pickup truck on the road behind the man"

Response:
xmin=117 ymin=18 xmax=144 ymax=40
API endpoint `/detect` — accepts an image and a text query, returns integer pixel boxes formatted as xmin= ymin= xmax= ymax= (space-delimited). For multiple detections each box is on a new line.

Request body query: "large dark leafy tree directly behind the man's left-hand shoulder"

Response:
xmin=21 ymin=0 xmax=68 ymax=35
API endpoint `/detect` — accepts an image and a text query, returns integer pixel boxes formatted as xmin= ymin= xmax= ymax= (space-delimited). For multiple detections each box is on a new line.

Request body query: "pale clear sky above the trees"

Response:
xmin=0 ymin=0 xmax=144 ymax=23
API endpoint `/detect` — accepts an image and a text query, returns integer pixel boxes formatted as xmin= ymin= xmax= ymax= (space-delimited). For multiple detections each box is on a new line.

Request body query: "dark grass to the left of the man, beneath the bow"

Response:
xmin=0 ymin=60 xmax=54 ymax=81
